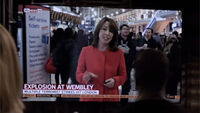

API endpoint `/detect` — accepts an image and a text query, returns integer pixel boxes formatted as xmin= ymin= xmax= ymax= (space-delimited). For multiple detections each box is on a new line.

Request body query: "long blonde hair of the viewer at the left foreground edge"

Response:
xmin=0 ymin=25 xmax=24 ymax=113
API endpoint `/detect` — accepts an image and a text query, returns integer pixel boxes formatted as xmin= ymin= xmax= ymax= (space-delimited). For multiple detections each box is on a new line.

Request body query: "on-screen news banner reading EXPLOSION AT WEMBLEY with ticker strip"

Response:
xmin=23 ymin=84 xmax=180 ymax=99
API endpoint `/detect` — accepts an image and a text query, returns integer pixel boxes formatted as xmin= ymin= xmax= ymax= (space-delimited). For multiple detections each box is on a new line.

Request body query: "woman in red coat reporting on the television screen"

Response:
xmin=76 ymin=17 xmax=126 ymax=101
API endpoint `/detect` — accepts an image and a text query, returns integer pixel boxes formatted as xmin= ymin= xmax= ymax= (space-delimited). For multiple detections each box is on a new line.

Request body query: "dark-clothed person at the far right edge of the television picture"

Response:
xmin=166 ymin=31 xmax=181 ymax=98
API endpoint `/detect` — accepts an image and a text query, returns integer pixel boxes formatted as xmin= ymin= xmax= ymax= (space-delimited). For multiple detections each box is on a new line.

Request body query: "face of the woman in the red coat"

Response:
xmin=99 ymin=22 xmax=113 ymax=44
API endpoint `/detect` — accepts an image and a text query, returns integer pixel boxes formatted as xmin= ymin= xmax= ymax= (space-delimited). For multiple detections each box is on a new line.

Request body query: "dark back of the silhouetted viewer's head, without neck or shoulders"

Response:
xmin=135 ymin=49 xmax=169 ymax=92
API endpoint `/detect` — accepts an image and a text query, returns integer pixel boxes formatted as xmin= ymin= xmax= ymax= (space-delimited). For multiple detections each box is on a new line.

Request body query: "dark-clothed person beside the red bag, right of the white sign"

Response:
xmin=53 ymin=28 xmax=77 ymax=84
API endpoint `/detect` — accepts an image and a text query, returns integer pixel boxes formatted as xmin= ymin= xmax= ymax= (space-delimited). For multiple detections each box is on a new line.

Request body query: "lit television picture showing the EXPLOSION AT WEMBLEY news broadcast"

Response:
xmin=17 ymin=5 xmax=182 ymax=103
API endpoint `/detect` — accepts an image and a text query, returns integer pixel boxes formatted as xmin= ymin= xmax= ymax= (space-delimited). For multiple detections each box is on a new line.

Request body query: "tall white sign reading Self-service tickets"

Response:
xmin=25 ymin=8 xmax=50 ymax=83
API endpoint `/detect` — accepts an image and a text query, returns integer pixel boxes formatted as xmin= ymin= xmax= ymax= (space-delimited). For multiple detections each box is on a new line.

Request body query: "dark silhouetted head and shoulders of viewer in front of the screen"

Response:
xmin=121 ymin=49 xmax=185 ymax=113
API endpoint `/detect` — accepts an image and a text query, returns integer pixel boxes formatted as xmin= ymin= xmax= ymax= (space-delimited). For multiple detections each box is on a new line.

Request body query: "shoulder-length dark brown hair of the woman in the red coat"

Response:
xmin=92 ymin=17 xmax=118 ymax=51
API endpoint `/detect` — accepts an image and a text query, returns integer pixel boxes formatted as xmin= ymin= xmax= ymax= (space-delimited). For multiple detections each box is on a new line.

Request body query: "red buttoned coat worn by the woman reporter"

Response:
xmin=76 ymin=46 xmax=126 ymax=101
